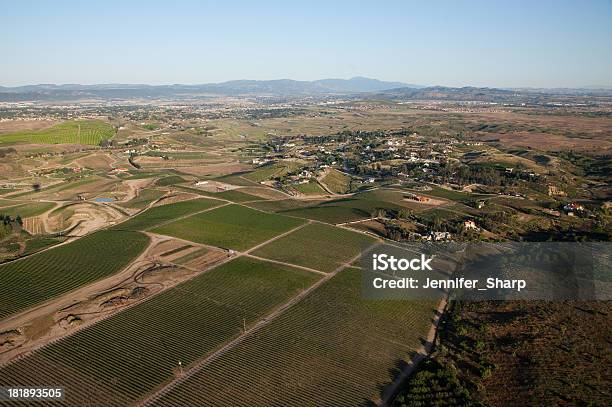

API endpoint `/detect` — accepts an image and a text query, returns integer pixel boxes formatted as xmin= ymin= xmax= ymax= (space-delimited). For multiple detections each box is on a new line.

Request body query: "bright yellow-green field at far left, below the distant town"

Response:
xmin=0 ymin=120 xmax=115 ymax=146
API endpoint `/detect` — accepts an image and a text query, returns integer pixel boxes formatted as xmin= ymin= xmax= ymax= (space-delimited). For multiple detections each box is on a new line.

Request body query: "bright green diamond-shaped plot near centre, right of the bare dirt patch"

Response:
xmin=152 ymin=205 xmax=304 ymax=250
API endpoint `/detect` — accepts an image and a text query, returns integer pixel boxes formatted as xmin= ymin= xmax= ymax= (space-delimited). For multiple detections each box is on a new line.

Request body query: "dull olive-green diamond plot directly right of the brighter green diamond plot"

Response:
xmin=253 ymin=223 xmax=375 ymax=272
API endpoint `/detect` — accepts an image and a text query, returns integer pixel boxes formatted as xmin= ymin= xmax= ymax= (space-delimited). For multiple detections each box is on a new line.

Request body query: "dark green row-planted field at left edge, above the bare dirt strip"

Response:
xmin=0 ymin=231 xmax=149 ymax=318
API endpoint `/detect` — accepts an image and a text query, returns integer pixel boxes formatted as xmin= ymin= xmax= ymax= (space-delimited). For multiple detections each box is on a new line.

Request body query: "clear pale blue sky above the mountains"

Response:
xmin=0 ymin=0 xmax=612 ymax=87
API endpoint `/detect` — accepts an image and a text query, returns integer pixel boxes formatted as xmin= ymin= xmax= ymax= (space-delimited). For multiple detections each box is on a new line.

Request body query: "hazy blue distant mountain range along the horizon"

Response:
xmin=0 ymin=77 xmax=612 ymax=102
